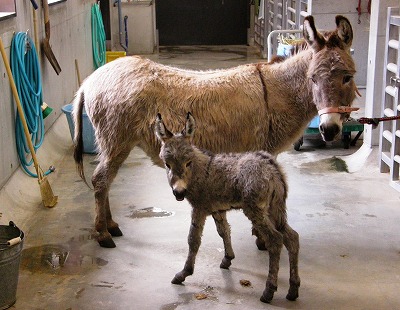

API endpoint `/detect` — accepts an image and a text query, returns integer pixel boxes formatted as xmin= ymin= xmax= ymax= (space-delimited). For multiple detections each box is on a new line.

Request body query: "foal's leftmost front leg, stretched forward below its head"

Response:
xmin=171 ymin=208 xmax=207 ymax=284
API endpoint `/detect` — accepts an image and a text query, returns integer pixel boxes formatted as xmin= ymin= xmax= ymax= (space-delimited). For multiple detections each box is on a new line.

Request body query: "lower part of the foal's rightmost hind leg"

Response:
xmin=282 ymin=223 xmax=300 ymax=301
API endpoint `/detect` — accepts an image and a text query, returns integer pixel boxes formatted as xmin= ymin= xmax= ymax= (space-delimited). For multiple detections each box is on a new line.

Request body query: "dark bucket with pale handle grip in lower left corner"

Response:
xmin=0 ymin=222 xmax=24 ymax=310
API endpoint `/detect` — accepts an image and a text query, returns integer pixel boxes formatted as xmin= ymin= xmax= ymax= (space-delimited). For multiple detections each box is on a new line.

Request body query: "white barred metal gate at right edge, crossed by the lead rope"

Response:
xmin=379 ymin=8 xmax=400 ymax=191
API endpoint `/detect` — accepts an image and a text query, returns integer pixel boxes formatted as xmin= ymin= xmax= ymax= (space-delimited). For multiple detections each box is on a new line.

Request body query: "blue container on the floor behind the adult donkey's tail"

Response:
xmin=61 ymin=103 xmax=97 ymax=154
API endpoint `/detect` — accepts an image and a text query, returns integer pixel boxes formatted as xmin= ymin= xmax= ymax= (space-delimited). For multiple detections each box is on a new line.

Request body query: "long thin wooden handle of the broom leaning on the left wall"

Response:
xmin=0 ymin=37 xmax=43 ymax=180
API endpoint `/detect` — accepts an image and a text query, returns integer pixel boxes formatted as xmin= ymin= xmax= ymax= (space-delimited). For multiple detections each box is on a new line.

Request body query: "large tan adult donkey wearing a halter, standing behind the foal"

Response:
xmin=73 ymin=16 xmax=356 ymax=247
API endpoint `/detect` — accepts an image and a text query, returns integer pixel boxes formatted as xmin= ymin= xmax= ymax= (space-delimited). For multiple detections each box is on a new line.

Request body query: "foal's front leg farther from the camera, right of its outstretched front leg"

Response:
xmin=212 ymin=211 xmax=235 ymax=269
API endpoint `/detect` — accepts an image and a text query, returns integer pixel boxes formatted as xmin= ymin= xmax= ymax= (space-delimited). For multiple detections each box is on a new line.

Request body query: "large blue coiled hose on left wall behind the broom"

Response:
xmin=10 ymin=32 xmax=53 ymax=178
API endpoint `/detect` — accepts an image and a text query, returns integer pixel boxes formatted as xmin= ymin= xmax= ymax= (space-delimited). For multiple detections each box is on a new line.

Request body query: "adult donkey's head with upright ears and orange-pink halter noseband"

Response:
xmin=303 ymin=15 xmax=358 ymax=141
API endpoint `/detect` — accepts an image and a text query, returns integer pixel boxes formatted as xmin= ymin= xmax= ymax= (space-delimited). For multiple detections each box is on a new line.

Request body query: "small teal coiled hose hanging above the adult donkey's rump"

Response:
xmin=91 ymin=3 xmax=106 ymax=69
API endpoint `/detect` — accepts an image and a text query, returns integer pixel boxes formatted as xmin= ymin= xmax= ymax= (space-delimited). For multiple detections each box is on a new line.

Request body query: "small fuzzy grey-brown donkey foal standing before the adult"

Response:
xmin=155 ymin=113 xmax=300 ymax=303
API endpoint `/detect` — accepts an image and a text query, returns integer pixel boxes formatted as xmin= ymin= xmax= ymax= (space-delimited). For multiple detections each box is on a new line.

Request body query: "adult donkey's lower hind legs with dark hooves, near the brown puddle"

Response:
xmin=92 ymin=149 xmax=130 ymax=248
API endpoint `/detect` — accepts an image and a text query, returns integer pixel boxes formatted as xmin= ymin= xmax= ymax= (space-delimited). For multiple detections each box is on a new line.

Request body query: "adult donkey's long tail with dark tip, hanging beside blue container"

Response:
xmin=72 ymin=88 xmax=91 ymax=188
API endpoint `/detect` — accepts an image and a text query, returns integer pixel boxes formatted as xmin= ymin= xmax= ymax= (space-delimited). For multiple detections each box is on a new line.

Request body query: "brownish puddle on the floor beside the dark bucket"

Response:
xmin=20 ymin=244 xmax=108 ymax=275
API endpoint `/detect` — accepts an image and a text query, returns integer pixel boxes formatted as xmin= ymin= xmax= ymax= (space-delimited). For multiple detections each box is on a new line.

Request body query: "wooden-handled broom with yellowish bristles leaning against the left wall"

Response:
xmin=0 ymin=38 xmax=58 ymax=208
